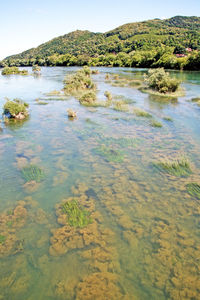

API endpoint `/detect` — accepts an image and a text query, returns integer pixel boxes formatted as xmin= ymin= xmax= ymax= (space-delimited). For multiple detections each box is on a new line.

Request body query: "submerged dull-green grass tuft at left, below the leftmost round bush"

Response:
xmin=22 ymin=164 xmax=45 ymax=182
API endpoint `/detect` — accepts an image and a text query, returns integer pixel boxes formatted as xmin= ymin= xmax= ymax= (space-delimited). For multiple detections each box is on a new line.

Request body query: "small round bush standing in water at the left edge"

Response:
xmin=3 ymin=99 xmax=29 ymax=120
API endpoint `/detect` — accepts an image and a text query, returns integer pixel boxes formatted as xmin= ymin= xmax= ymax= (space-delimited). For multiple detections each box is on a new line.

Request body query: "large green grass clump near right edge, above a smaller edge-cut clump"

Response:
xmin=154 ymin=158 xmax=192 ymax=177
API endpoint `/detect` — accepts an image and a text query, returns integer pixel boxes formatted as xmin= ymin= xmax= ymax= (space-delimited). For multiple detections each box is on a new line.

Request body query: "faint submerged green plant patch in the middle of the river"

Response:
xmin=94 ymin=145 xmax=124 ymax=162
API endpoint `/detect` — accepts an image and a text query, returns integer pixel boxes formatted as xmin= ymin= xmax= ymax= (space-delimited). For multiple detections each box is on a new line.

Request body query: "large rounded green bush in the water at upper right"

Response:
xmin=145 ymin=68 xmax=180 ymax=94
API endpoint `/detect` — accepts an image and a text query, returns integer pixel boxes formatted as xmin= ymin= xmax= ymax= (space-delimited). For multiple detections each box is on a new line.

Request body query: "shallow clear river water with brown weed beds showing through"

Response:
xmin=0 ymin=67 xmax=200 ymax=300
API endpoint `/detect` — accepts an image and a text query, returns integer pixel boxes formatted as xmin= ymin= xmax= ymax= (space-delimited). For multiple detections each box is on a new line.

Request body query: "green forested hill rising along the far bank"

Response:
xmin=1 ymin=16 xmax=200 ymax=69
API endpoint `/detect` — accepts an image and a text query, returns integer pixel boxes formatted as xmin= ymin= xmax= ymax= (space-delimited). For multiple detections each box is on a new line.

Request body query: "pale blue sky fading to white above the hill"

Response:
xmin=0 ymin=0 xmax=200 ymax=59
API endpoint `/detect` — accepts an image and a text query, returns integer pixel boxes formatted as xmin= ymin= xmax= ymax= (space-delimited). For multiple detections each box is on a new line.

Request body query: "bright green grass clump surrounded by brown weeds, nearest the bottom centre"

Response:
xmin=62 ymin=200 xmax=93 ymax=228
